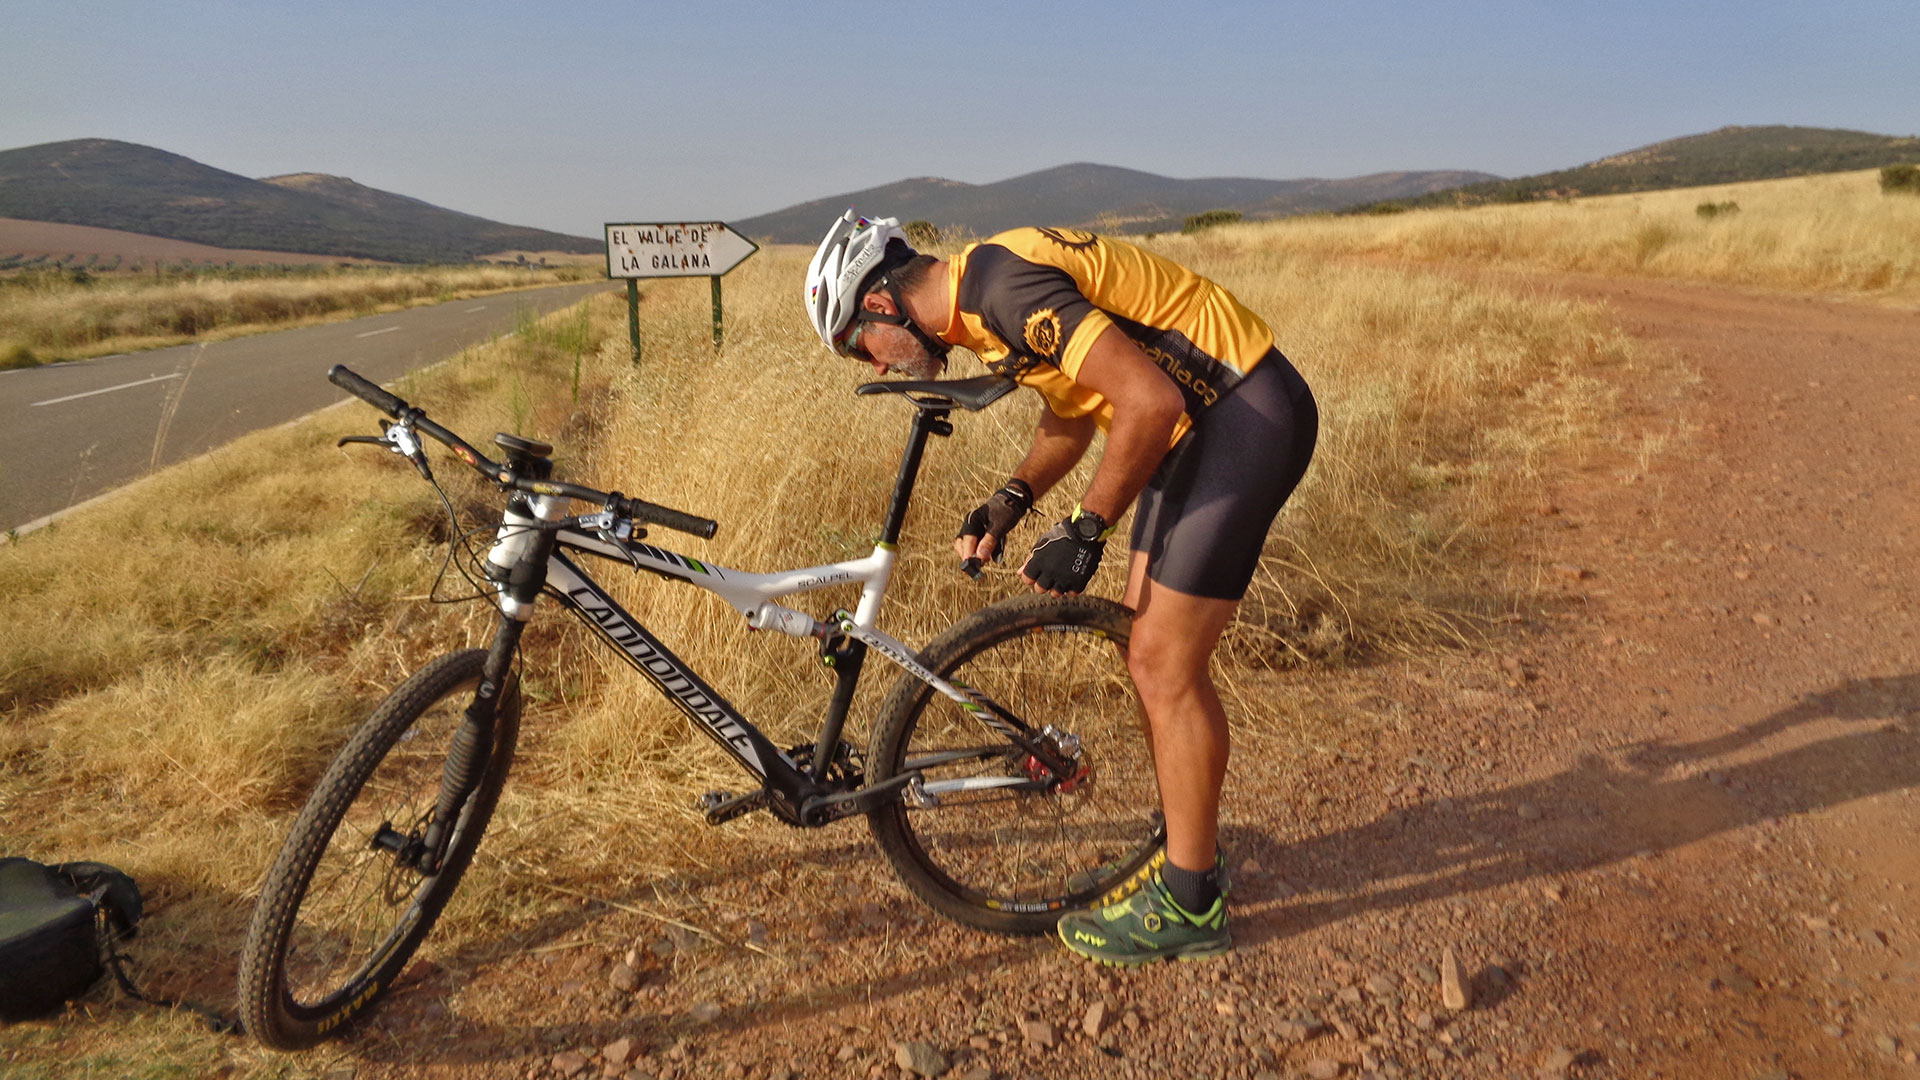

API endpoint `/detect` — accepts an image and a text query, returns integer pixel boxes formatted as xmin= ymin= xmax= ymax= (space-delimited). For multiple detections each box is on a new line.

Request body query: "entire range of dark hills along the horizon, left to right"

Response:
xmin=0 ymin=127 xmax=1920 ymax=261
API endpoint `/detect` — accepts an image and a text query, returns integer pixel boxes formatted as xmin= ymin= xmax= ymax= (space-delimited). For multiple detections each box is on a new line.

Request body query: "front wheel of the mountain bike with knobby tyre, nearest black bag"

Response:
xmin=240 ymin=650 xmax=518 ymax=1049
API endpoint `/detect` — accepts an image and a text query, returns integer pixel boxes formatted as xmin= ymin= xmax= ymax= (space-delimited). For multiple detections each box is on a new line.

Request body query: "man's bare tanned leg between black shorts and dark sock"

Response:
xmin=1125 ymin=552 xmax=1238 ymax=871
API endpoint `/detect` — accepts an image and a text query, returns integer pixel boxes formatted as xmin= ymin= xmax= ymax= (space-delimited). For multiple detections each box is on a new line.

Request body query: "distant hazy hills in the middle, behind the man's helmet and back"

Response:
xmin=730 ymin=163 xmax=1492 ymax=244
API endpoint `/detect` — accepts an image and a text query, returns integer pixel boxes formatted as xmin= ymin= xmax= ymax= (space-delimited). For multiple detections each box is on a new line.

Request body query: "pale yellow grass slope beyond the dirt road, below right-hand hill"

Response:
xmin=1217 ymin=169 xmax=1920 ymax=302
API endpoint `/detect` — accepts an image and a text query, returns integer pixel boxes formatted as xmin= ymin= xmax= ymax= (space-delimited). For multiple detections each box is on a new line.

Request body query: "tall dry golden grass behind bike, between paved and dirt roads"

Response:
xmin=0 ymin=224 xmax=1638 ymax=1072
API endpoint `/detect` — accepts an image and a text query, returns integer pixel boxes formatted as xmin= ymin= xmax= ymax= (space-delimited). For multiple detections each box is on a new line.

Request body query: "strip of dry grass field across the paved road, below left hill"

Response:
xmin=0 ymin=265 xmax=599 ymax=369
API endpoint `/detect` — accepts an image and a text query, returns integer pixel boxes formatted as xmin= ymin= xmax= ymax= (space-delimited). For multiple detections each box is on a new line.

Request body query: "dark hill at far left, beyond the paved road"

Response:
xmin=0 ymin=138 xmax=603 ymax=263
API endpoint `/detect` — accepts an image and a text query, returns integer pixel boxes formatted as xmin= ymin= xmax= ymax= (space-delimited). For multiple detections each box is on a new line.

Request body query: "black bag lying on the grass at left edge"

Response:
xmin=0 ymin=859 xmax=140 ymax=1020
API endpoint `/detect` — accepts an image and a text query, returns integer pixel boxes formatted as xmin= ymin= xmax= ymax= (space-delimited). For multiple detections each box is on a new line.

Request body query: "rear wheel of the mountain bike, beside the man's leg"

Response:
xmin=868 ymin=596 xmax=1164 ymax=934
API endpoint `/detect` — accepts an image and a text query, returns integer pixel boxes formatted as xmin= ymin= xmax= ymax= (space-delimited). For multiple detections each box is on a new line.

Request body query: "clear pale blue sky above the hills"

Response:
xmin=0 ymin=0 xmax=1920 ymax=236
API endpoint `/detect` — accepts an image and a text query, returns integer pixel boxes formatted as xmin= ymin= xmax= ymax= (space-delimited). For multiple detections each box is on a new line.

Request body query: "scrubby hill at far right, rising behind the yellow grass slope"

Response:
xmin=1356 ymin=125 xmax=1920 ymax=211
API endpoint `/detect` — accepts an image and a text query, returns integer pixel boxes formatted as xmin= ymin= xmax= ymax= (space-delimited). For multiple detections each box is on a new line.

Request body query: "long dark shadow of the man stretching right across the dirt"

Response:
xmin=1236 ymin=675 xmax=1920 ymax=947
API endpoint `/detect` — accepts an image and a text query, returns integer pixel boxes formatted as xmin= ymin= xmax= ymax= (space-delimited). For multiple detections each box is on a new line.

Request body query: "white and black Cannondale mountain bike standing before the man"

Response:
xmin=240 ymin=367 xmax=1164 ymax=1049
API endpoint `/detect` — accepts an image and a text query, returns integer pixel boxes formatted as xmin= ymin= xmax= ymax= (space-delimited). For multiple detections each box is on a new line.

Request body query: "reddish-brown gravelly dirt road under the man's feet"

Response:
xmin=307 ymin=277 xmax=1920 ymax=1080
